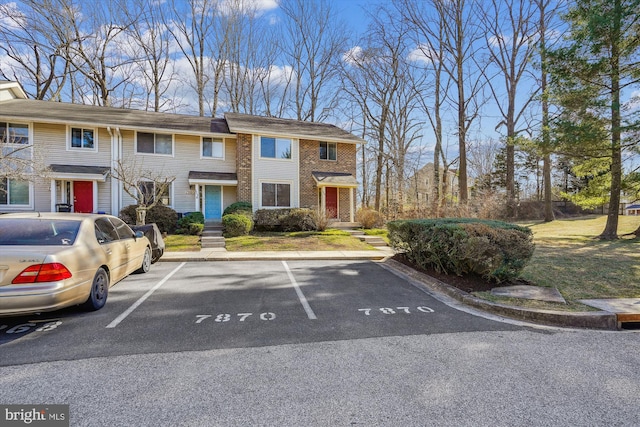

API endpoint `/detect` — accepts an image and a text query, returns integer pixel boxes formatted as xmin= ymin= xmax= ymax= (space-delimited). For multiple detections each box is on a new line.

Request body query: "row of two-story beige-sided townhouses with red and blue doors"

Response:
xmin=0 ymin=81 xmax=364 ymax=222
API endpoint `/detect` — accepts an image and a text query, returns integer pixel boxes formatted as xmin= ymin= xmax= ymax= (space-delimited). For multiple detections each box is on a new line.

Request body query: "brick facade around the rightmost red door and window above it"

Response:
xmin=300 ymin=139 xmax=357 ymax=221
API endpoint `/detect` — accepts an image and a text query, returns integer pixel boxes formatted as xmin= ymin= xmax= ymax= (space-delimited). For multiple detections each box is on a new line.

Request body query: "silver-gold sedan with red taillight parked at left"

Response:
xmin=0 ymin=212 xmax=151 ymax=316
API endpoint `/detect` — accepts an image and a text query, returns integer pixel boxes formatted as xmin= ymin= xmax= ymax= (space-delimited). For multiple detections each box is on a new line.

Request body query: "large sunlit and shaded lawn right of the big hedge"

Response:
xmin=478 ymin=216 xmax=640 ymax=309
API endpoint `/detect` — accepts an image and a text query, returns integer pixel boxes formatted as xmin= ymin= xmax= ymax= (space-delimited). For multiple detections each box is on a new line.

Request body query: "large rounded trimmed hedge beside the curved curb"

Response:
xmin=387 ymin=218 xmax=534 ymax=282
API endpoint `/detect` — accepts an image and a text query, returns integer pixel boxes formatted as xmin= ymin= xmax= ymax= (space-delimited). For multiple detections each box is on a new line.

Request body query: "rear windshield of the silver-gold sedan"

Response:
xmin=0 ymin=218 xmax=81 ymax=246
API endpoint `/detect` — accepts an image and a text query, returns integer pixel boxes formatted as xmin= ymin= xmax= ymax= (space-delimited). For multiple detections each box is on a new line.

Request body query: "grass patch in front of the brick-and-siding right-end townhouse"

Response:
xmin=225 ymin=229 xmax=375 ymax=251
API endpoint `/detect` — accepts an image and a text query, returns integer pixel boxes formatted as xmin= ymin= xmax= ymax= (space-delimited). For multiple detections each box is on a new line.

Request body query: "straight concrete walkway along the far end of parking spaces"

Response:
xmin=160 ymin=247 xmax=394 ymax=262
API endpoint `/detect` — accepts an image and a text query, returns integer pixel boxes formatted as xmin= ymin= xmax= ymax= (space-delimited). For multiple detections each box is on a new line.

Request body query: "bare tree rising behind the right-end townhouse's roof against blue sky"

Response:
xmin=279 ymin=0 xmax=348 ymax=122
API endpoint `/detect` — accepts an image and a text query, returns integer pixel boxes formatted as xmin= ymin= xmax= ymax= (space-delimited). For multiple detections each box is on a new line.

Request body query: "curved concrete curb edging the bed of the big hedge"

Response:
xmin=384 ymin=259 xmax=618 ymax=330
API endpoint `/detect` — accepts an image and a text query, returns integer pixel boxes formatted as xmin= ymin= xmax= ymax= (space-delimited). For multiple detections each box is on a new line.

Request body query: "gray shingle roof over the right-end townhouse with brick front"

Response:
xmin=224 ymin=113 xmax=364 ymax=144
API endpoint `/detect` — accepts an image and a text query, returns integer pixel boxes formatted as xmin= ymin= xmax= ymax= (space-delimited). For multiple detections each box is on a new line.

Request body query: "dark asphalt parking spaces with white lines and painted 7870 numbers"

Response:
xmin=0 ymin=260 xmax=522 ymax=366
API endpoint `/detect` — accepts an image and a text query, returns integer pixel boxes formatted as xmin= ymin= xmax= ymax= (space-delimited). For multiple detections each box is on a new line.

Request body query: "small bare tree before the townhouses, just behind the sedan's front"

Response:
xmin=111 ymin=160 xmax=176 ymax=225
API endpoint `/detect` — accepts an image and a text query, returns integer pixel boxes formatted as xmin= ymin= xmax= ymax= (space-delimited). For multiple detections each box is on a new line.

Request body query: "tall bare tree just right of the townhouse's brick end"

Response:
xmin=343 ymin=8 xmax=424 ymax=211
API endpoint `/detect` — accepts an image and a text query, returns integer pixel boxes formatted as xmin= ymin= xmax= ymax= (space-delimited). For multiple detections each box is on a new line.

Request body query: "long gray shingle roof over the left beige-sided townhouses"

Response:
xmin=0 ymin=99 xmax=229 ymax=133
